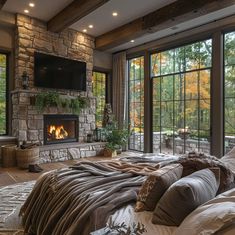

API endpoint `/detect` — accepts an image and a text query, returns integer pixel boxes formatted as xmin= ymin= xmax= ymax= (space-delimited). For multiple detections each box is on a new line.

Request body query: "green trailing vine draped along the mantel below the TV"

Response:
xmin=35 ymin=92 xmax=89 ymax=114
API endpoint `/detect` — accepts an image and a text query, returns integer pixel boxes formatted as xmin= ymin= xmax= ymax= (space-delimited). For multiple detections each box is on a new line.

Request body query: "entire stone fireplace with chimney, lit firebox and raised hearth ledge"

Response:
xmin=11 ymin=14 xmax=104 ymax=163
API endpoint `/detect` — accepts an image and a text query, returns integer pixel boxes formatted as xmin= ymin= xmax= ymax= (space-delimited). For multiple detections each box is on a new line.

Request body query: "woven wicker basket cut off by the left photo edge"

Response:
xmin=1 ymin=144 xmax=17 ymax=167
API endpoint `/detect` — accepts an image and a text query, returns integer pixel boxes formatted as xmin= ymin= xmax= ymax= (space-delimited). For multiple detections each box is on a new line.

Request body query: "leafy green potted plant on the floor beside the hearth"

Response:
xmin=103 ymin=123 xmax=129 ymax=157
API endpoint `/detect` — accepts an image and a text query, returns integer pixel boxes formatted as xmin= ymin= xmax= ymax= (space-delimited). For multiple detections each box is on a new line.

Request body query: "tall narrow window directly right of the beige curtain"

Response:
xmin=128 ymin=56 xmax=144 ymax=151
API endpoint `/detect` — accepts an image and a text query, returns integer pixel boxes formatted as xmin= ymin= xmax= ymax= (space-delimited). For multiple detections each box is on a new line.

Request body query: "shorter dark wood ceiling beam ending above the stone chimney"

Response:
xmin=47 ymin=0 xmax=109 ymax=33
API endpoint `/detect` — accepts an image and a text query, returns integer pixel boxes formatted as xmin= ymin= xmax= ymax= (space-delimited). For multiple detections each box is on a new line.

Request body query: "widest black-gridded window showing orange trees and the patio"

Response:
xmin=151 ymin=39 xmax=212 ymax=154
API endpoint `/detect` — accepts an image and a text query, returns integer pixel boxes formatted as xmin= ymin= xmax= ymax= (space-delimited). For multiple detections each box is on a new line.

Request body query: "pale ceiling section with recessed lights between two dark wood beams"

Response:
xmin=71 ymin=0 xmax=176 ymax=36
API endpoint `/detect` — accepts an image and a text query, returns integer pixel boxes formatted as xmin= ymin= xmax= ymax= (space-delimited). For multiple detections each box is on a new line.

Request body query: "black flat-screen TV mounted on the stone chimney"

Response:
xmin=34 ymin=52 xmax=86 ymax=91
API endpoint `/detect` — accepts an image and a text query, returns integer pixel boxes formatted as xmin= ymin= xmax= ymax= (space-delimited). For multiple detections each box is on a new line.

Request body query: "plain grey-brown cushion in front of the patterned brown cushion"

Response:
xmin=152 ymin=169 xmax=219 ymax=226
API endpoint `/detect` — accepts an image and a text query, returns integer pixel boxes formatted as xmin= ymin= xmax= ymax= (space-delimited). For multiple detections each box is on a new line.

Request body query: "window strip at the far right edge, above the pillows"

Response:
xmin=224 ymin=32 xmax=235 ymax=152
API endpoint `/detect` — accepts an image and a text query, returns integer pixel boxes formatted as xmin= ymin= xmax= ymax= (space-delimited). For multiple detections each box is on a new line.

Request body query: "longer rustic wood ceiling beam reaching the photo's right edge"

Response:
xmin=95 ymin=0 xmax=235 ymax=50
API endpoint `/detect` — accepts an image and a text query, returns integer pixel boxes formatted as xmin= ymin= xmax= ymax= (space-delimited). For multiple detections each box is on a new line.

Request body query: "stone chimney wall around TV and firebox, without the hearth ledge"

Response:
xmin=11 ymin=14 xmax=96 ymax=146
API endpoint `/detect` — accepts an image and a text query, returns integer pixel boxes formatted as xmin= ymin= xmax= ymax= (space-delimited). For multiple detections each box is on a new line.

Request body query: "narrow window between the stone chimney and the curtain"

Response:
xmin=92 ymin=72 xmax=107 ymax=127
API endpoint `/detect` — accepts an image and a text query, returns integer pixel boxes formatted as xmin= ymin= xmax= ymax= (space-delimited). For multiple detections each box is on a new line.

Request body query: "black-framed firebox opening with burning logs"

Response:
xmin=44 ymin=114 xmax=78 ymax=144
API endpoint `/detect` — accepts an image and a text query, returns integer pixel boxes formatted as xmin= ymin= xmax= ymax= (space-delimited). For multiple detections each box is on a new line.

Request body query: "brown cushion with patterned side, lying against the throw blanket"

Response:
xmin=135 ymin=164 xmax=183 ymax=211
